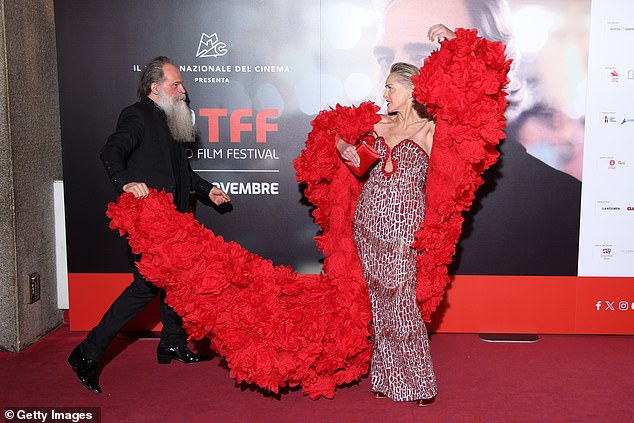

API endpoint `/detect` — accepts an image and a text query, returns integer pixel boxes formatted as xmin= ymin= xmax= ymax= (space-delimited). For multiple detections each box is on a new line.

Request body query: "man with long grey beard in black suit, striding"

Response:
xmin=68 ymin=56 xmax=229 ymax=393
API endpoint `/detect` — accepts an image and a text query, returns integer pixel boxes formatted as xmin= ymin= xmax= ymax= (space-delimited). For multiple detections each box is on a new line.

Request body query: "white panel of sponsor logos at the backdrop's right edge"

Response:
xmin=579 ymin=0 xmax=634 ymax=276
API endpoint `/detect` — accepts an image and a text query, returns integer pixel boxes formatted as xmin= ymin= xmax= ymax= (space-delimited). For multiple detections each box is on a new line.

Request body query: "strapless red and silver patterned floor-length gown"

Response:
xmin=354 ymin=137 xmax=437 ymax=401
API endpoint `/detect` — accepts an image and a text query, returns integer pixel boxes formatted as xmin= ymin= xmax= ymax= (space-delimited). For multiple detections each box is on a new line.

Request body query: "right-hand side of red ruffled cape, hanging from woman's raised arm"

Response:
xmin=412 ymin=29 xmax=511 ymax=322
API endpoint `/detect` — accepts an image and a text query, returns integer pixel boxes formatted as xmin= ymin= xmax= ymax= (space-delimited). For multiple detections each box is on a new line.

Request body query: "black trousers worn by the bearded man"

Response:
xmin=79 ymin=268 xmax=187 ymax=361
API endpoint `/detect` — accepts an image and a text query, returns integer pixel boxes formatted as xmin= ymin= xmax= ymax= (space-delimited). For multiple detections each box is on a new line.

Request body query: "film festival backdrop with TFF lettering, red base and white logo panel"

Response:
xmin=55 ymin=0 xmax=634 ymax=333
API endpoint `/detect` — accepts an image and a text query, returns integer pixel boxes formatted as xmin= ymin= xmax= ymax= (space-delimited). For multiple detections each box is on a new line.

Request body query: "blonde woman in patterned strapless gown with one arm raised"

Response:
xmin=337 ymin=25 xmax=455 ymax=406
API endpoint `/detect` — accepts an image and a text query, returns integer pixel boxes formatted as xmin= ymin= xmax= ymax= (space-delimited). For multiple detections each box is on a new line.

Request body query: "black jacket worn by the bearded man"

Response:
xmin=100 ymin=98 xmax=213 ymax=212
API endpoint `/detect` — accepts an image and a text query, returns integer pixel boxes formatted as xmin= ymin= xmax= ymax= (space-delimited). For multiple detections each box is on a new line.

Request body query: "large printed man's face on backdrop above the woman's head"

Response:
xmin=374 ymin=0 xmax=473 ymax=78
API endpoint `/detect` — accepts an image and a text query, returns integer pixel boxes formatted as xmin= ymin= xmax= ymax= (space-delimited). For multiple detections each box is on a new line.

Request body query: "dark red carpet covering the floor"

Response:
xmin=0 ymin=325 xmax=634 ymax=423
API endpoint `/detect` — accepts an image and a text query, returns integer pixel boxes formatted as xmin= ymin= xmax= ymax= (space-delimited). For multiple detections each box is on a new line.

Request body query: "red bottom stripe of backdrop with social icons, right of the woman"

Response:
xmin=429 ymin=275 xmax=634 ymax=334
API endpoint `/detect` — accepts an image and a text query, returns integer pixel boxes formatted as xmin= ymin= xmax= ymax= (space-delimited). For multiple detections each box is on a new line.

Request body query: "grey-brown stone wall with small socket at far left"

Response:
xmin=0 ymin=0 xmax=62 ymax=351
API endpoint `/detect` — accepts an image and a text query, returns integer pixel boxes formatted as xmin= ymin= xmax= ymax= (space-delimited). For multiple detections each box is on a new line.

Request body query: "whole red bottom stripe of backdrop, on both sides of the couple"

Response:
xmin=68 ymin=273 xmax=634 ymax=335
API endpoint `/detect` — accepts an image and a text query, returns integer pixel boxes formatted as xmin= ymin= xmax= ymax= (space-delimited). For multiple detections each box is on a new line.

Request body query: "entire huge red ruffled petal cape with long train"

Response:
xmin=107 ymin=30 xmax=510 ymax=399
